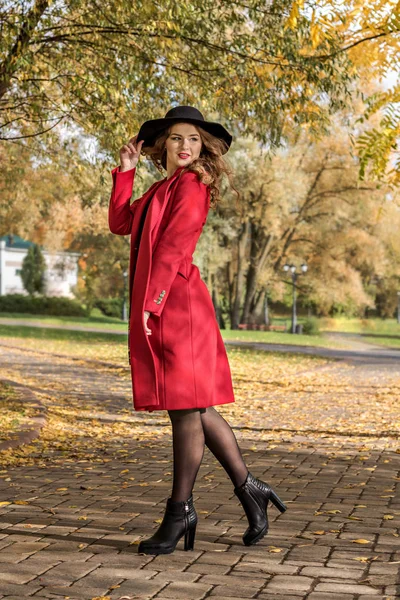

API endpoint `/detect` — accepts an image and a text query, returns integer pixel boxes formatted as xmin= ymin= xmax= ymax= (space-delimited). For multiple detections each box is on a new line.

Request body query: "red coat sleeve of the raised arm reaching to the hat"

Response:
xmin=108 ymin=167 xmax=136 ymax=235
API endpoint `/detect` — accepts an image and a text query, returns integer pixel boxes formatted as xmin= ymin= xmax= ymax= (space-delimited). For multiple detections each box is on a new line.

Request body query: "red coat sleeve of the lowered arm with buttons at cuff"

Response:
xmin=144 ymin=171 xmax=209 ymax=317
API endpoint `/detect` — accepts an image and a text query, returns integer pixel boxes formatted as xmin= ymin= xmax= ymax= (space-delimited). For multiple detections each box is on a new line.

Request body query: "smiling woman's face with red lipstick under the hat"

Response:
xmin=165 ymin=123 xmax=202 ymax=172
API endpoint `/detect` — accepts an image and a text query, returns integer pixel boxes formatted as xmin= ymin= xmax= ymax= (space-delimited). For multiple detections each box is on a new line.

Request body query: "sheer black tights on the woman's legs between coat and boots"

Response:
xmin=168 ymin=406 xmax=248 ymax=502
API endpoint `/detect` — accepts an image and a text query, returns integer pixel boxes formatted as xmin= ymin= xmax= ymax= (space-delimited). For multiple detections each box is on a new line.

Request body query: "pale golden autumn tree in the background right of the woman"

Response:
xmin=218 ymin=124 xmax=400 ymax=328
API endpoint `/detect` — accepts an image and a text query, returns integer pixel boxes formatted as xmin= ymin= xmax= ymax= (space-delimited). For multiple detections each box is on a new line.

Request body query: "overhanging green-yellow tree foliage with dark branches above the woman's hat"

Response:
xmin=0 ymin=0 xmax=352 ymax=155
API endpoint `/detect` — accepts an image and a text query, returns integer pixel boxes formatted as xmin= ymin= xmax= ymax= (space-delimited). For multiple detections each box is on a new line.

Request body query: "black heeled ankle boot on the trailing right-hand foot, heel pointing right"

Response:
xmin=234 ymin=472 xmax=286 ymax=546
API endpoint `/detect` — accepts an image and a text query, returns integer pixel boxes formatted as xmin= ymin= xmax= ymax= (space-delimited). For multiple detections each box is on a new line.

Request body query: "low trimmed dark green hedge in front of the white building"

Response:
xmin=0 ymin=294 xmax=85 ymax=317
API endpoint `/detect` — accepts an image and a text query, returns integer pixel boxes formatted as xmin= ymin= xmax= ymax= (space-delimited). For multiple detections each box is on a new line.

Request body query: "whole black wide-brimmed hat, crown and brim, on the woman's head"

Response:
xmin=137 ymin=106 xmax=232 ymax=154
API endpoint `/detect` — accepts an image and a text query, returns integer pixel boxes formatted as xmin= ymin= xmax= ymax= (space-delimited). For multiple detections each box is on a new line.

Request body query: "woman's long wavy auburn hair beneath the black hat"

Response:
xmin=142 ymin=120 xmax=239 ymax=208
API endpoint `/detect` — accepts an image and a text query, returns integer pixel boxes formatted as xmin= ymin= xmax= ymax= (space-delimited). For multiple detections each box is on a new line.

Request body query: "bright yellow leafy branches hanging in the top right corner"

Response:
xmin=287 ymin=0 xmax=400 ymax=186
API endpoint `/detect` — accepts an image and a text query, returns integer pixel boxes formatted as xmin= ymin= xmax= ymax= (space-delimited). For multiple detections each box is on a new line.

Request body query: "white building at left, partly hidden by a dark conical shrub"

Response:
xmin=0 ymin=234 xmax=79 ymax=298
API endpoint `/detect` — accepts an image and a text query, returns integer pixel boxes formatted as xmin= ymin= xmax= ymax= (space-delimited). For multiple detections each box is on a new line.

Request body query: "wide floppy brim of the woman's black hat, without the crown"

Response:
xmin=137 ymin=117 xmax=232 ymax=154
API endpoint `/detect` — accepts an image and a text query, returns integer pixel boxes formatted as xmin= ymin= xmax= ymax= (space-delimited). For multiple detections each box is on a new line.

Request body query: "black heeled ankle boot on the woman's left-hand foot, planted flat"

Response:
xmin=138 ymin=496 xmax=197 ymax=554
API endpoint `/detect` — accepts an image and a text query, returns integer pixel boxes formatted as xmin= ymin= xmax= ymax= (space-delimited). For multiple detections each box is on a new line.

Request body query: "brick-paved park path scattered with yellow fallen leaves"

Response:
xmin=0 ymin=342 xmax=400 ymax=600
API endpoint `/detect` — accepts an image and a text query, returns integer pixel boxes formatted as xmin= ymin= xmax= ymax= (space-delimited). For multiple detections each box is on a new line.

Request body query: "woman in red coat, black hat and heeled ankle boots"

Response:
xmin=109 ymin=106 xmax=286 ymax=554
